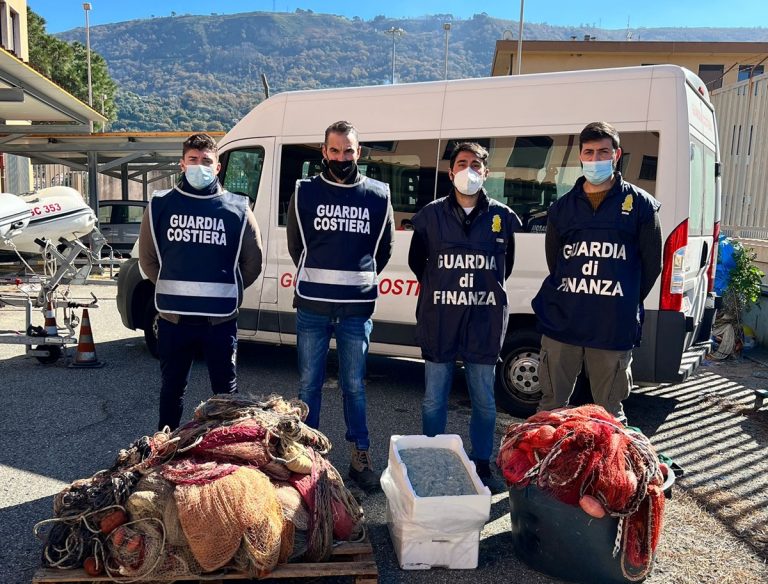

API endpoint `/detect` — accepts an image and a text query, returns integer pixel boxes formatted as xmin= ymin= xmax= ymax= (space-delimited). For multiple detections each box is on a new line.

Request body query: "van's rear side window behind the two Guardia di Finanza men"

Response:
xmin=444 ymin=132 xmax=659 ymax=233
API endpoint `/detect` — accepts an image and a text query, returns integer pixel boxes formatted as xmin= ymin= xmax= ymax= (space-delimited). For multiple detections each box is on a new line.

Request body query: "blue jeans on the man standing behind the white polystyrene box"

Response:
xmin=421 ymin=361 xmax=496 ymax=460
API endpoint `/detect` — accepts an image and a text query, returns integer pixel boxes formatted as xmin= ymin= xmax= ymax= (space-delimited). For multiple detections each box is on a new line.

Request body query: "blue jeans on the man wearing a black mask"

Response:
xmin=296 ymin=308 xmax=373 ymax=450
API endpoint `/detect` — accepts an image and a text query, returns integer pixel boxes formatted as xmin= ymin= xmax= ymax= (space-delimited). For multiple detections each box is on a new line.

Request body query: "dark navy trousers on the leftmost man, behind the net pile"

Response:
xmin=157 ymin=317 xmax=237 ymax=430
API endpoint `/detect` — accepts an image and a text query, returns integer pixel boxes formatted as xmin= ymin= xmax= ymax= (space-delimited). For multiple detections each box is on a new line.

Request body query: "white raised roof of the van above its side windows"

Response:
xmin=220 ymin=65 xmax=708 ymax=146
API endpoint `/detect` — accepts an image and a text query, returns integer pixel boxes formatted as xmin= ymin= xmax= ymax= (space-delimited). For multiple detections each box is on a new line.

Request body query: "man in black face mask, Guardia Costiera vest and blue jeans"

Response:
xmin=286 ymin=121 xmax=394 ymax=491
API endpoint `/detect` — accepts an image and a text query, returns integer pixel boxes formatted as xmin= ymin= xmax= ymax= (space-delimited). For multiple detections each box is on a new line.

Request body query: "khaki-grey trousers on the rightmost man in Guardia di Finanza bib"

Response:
xmin=538 ymin=335 xmax=632 ymax=421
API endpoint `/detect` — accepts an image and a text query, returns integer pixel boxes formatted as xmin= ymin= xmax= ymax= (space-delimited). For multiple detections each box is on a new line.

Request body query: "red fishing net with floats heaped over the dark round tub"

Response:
xmin=497 ymin=404 xmax=664 ymax=580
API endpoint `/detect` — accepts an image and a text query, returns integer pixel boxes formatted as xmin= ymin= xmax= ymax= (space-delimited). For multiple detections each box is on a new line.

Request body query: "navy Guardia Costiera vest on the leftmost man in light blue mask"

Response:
xmin=149 ymin=187 xmax=247 ymax=316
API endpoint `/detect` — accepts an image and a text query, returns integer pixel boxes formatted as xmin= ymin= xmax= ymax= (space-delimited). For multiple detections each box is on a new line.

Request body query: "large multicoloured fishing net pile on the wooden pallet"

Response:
xmin=35 ymin=395 xmax=365 ymax=581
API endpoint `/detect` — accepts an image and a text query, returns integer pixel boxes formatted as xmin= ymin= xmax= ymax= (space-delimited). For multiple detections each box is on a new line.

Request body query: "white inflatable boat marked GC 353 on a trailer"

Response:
xmin=0 ymin=186 xmax=96 ymax=254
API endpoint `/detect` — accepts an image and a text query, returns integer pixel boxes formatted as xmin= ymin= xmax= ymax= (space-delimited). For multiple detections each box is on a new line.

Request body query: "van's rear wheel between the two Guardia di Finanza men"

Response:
xmin=495 ymin=329 xmax=541 ymax=418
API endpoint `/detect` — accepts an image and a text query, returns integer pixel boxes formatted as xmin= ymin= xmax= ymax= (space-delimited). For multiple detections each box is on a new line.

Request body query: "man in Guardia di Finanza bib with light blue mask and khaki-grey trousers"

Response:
xmin=532 ymin=122 xmax=662 ymax=422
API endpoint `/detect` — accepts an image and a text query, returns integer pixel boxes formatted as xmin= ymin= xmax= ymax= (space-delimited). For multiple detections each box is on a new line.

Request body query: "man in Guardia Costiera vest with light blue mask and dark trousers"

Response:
xmin=139 ymin=134 xmax=262 ymax=430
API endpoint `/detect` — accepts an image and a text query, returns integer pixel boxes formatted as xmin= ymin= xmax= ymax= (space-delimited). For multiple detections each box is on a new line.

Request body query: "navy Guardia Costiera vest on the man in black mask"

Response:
xmin=294 ymin=175 xmax=389 ymax=302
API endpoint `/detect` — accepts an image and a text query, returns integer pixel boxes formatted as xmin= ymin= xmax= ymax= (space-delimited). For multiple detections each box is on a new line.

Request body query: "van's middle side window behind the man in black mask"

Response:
xmin=278 ymin=140 xmax=438 ymax=230
